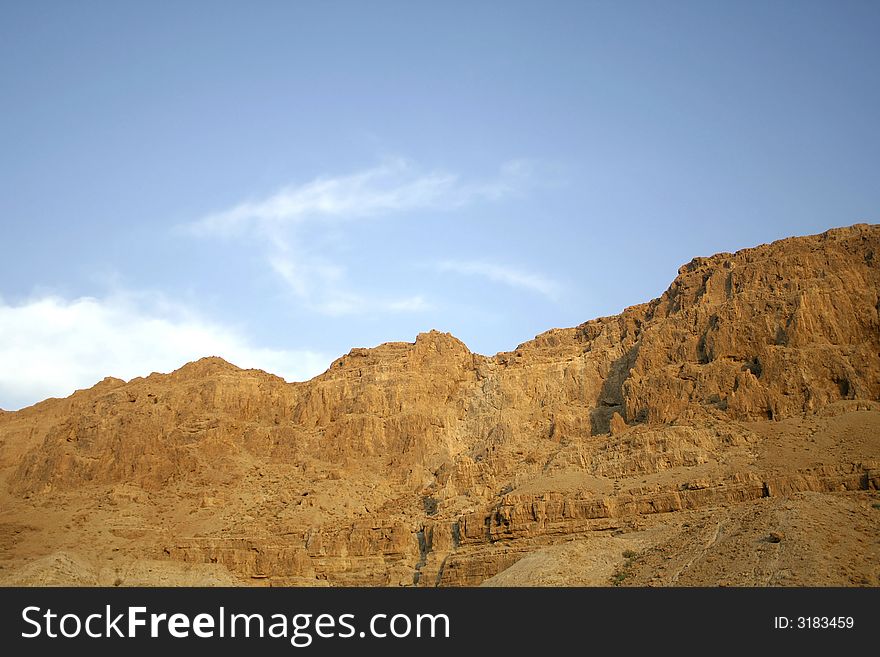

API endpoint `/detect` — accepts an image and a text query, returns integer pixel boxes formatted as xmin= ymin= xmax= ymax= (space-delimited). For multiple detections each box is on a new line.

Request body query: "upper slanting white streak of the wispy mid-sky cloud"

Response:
xmin=191 ymin=158 xmax=531 ymax=236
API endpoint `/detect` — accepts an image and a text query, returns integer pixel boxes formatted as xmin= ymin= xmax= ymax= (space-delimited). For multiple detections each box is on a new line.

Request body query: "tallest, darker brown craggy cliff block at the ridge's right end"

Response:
xmin=624 ymin=225 xmax=880 ymax=422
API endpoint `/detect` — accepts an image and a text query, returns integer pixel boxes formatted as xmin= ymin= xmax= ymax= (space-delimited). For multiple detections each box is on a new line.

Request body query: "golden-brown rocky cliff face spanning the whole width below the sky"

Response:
xmin=0 ymin=225 xmax=880 ymax=585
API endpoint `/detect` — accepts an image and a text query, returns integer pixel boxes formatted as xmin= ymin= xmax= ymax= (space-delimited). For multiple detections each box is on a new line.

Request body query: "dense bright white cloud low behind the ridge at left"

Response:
xmin=0 ymin=293 xmax=332 ymax=410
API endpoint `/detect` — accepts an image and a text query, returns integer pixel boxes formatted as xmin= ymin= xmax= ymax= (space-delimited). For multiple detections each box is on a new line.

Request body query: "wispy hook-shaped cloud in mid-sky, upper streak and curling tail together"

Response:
xmin=188 ymin=158 xmax=532 ymax=315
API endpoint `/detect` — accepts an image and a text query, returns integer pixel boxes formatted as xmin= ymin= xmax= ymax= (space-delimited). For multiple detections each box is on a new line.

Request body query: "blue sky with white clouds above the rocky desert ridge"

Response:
xmin=0 ymin=0 xmax=880 ymax=410
